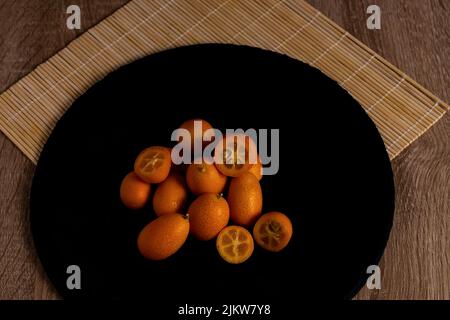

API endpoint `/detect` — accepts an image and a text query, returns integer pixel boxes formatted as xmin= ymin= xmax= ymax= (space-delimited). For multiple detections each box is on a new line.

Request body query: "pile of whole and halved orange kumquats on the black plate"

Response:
xmin=120 ymin=120 xmax=292 ymax=264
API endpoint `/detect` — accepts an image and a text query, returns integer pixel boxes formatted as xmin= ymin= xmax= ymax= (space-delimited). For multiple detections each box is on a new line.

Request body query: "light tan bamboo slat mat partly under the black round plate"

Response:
xmin=0 ymin=0 xmax=449 ymax=163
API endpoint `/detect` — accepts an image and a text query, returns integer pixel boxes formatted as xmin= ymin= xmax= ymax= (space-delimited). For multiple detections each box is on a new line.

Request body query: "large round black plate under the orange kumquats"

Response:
xmin=31 ymin=44 xmax=394 ymax=306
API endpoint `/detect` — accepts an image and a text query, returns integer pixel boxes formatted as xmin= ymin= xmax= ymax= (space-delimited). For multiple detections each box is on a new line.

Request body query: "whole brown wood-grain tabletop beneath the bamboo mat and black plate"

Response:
xmin=0 ymin=0 xmax=450 ymax=299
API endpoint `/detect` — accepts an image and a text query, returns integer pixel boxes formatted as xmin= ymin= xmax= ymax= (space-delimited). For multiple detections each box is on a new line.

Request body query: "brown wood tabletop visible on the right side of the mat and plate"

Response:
xmin=310 ymin=0 xmax=450 ymax=299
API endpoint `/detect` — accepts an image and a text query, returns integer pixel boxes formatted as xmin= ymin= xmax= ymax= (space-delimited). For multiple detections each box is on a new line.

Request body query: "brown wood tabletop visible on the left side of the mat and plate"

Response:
xmin=0 ymin=0 xmax=127 ymax=299
